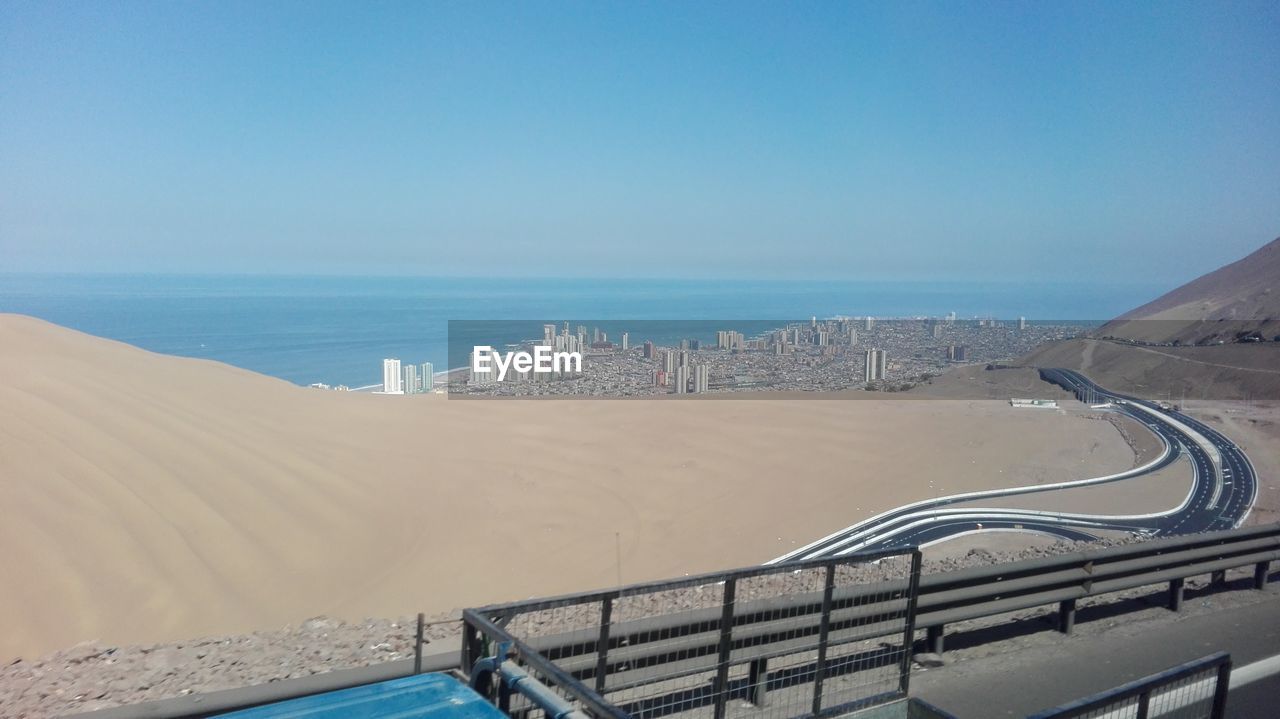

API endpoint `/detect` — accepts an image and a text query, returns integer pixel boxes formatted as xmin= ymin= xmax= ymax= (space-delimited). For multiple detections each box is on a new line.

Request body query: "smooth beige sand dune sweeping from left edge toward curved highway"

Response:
xmin=0 ymin=315 xmax=1134 ymax=660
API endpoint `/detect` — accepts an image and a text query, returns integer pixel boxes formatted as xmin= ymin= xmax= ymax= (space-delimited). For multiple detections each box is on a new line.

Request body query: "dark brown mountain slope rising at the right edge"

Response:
xmin=1098 ymin=238 xmax=1280 ymax=344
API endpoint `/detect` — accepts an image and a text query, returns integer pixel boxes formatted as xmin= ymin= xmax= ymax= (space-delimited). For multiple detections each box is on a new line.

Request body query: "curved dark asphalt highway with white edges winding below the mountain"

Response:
xmin=769 ymin=368 xmax=1257 ymax=564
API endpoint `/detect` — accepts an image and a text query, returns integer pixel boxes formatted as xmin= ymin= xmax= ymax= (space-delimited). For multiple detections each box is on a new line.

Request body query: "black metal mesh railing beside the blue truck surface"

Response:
xmin=462 ymin=550 xmax=920 ymax=719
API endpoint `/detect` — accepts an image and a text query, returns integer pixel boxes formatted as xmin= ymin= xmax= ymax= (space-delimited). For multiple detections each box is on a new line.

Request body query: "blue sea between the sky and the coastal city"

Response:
xmin=0 ymin=274 xmax=1167 ymax=388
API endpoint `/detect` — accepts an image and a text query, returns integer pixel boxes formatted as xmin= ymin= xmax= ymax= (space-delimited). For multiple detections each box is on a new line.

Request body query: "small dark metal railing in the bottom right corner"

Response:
xmin=1028 ymin=652 xmax=1231 ymax=719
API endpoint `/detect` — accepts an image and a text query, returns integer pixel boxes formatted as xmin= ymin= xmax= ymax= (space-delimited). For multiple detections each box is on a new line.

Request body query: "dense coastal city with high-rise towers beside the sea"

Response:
xmin=448 ymin=313 xmax=1088 ymax=397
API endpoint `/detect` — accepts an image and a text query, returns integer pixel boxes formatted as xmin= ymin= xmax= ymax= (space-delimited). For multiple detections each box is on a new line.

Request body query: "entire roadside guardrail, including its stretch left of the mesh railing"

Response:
xmin=64 ymin=523 xmax=1280 ymax=719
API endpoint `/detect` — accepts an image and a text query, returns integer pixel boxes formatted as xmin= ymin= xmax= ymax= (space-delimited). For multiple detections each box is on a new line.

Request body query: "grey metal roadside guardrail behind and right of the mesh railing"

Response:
xmin=483 ymin=523 xmax=1280 ymax=679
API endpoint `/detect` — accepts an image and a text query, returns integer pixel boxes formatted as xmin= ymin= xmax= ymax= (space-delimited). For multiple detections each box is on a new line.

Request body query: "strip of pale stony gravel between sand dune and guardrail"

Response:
xmin=0 ymin=532 xmax=1167 ymax=719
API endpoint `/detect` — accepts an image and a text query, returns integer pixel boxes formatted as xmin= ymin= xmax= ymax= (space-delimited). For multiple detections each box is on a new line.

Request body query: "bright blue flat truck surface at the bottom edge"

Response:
xmin=219 ymin=674 xmax=507 ymax=719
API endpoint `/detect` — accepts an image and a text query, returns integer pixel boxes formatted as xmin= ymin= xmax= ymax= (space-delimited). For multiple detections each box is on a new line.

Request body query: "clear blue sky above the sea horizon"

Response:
xmin=0 ymin=0 xmax=1280 ymax=281
